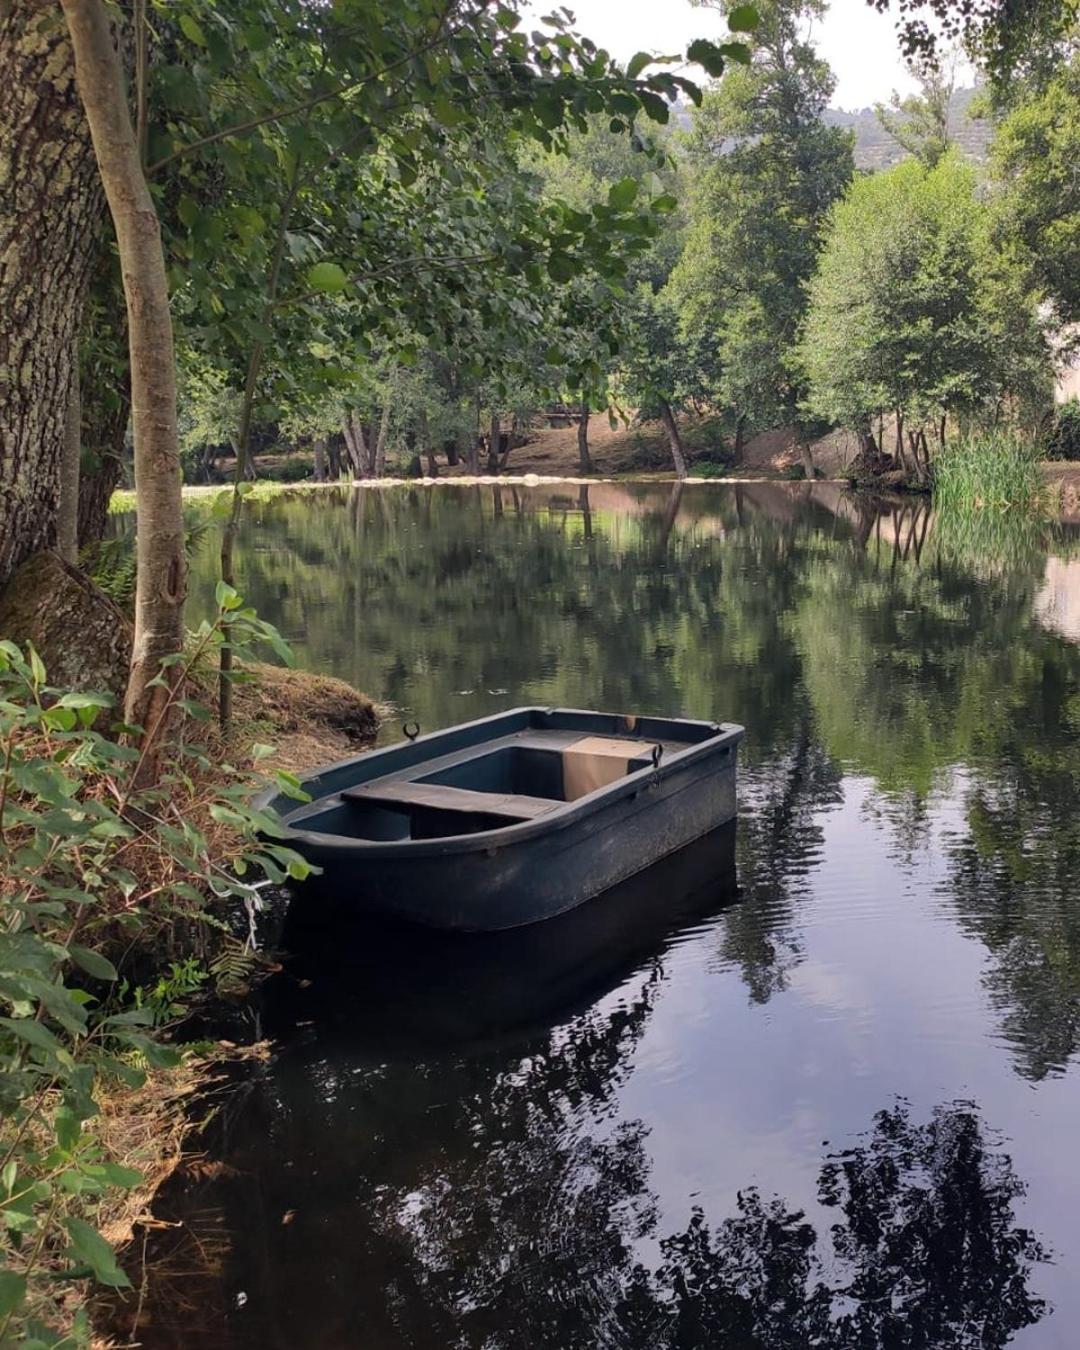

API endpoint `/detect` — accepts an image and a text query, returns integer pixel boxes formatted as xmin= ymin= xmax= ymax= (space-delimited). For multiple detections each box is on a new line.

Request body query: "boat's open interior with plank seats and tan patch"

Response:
xmin=288 ymin=718 xmax=718 ymax=841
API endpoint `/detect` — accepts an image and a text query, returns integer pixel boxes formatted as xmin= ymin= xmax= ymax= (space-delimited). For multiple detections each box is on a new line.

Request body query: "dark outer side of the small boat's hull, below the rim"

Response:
xmin=265 ymin=710 xmax=743 ymax=932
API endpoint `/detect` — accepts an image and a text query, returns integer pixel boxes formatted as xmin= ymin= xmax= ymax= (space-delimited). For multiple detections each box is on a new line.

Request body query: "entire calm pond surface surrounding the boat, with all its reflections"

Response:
xmin=139 ymin=483 xmax=1080 ymax=1350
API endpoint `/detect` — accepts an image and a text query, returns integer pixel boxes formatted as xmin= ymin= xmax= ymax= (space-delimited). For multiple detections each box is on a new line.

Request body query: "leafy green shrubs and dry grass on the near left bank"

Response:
xmin=0 ymin=590 xmax=308 ymax=1345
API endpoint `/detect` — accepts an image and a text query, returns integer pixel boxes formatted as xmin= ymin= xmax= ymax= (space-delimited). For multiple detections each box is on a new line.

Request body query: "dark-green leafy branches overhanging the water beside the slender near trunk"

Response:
xmin=139 ymin=0 xmax=744 ymax=480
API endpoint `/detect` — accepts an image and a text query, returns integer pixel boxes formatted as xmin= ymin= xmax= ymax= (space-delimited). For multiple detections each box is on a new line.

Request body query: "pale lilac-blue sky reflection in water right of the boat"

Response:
xmin=620 ymin=779 xmax=1080 ymax=1350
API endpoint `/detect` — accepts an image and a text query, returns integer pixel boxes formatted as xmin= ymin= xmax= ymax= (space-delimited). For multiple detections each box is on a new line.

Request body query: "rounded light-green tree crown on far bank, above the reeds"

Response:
xmin=801 ymin=154 xmax=1050 ymax=437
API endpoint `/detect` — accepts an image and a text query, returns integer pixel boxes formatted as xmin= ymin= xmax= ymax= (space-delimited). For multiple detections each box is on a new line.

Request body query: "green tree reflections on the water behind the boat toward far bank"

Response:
xmin=176 ymin=485 xmax=1080 ymax=1076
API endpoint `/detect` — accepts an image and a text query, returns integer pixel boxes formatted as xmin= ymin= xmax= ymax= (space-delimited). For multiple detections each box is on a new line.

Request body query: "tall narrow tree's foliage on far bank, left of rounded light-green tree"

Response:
xmin=671 ymin=0 xmax=853 ymax=427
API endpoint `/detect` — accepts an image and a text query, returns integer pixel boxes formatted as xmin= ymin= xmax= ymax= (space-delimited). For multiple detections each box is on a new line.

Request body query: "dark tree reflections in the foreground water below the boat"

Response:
xmin=147 ymin=961 xmax=1048 ymax=1350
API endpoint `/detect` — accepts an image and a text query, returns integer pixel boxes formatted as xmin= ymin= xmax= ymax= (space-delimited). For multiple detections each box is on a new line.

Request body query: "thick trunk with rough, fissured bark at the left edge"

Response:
xmin=0 ymin=0 xmax=104 ymax=585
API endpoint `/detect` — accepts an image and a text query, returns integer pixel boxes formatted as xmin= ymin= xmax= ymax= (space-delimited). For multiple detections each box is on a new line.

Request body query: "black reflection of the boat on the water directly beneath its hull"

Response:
xmin=270 ymin=822 xmax=738 ymax=1056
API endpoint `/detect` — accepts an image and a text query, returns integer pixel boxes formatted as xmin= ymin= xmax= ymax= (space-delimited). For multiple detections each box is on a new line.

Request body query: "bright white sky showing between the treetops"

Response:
xmin=525 ymin=0 xmax=914 ymax=111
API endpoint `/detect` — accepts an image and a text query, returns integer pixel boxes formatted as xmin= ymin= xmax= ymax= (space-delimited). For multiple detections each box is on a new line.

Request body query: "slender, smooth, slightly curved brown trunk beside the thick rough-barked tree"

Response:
xmin=61 ymin=0 xmax=186 ymax=782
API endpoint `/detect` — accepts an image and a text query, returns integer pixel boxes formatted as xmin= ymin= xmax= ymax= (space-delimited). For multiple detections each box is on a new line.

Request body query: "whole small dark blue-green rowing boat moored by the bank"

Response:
xmin=258 ymin=707 xmax=743 ymax=932
